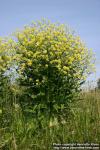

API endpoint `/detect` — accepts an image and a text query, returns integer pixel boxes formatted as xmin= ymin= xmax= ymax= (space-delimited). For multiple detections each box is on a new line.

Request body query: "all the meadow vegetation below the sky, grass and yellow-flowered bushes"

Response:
xmin=0 ymin=20 xmax=100 ymax=150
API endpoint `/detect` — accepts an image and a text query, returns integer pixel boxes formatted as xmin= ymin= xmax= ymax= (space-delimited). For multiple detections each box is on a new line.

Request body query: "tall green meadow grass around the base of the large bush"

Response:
xmin=0 ymin=81 xmax=100 ymax=150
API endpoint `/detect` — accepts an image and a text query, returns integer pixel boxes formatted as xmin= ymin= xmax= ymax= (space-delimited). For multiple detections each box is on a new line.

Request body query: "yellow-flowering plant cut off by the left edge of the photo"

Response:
xmin=0 ymin=38 xmax=15 ymax=130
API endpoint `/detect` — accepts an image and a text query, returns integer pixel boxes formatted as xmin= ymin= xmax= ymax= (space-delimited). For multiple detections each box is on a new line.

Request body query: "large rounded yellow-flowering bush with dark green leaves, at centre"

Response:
xmin=13 ymin=21 xmax=93 ymax=125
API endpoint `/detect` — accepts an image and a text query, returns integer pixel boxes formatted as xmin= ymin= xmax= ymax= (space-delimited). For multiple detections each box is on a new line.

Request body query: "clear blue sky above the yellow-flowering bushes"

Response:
xmin=0 ymin=0 xmax=100 ymax=80
